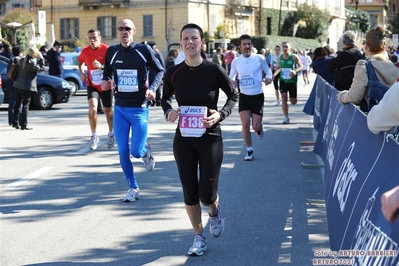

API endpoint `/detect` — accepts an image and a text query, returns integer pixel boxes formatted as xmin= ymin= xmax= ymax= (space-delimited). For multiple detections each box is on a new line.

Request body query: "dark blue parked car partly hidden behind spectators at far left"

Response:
xmin=0 ymin=56 xmax=72 ymax=110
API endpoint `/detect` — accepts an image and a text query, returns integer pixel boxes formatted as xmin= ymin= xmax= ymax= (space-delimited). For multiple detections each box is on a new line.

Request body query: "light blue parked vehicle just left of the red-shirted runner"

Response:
xmin=61 ymin=52 xmax=87 ymax=95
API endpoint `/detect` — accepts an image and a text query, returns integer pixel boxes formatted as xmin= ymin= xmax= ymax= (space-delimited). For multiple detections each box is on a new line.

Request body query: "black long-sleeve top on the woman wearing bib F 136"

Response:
xmin=161 ymin=60 xmax=238 ymax=135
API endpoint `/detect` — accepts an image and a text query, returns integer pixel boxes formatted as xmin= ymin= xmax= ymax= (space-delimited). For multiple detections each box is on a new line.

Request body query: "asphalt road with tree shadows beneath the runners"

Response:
xmin=0 ymin=74 xmax=329 ymax=266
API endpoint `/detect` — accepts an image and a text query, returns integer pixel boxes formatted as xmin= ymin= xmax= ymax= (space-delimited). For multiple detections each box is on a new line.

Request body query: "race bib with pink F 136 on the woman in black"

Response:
xmin=179 ymin=106 xmax=207 ymax=138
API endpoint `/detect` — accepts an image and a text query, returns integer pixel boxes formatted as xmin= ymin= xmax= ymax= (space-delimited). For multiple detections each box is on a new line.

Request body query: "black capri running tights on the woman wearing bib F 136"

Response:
xmin=173 ymin=129 xmax=223 ymax=205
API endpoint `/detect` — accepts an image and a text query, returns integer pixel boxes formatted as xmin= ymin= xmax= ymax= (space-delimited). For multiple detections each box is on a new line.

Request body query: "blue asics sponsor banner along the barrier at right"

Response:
xmin=314 ymin=77 xmax=399 ymax=265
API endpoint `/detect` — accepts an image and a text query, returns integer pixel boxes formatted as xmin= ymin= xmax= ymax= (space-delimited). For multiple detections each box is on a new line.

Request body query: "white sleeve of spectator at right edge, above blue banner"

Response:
xmin=367 ymin=82 xmax=399 ymax=134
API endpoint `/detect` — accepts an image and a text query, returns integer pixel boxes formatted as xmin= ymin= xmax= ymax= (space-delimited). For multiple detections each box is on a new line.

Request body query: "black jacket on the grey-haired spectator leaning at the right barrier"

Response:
xmin=328 ymin=47 xmax=364 ymax=91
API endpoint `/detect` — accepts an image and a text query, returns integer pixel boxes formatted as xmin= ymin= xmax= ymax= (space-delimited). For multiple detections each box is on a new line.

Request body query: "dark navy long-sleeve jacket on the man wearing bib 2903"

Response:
xmin=103 ymin=43 xmax=164 ymax=107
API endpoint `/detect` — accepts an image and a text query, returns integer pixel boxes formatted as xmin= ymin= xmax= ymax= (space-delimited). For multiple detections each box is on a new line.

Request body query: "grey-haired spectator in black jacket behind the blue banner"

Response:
xmin=328 ymin=31 xmax=364 ymax=91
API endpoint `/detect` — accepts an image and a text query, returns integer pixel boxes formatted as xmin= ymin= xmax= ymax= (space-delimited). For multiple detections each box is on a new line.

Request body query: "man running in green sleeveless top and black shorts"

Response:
xmin=273 ymin=42 xmax=302 ymax=124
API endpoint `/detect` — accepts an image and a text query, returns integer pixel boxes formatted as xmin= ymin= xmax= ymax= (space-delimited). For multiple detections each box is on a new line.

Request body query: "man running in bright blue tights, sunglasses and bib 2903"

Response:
xmin=101 ymin=18 xmax=164 ymax=202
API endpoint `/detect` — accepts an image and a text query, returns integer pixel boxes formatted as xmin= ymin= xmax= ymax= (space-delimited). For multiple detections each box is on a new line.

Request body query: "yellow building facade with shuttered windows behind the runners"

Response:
xmin=0 ymin=0 xmax=346 ymax=54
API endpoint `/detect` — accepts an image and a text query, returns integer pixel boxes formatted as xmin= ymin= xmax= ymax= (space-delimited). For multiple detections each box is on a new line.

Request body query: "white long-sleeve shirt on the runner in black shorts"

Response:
xmin=229 ymin=53 xmax=273 ymax=95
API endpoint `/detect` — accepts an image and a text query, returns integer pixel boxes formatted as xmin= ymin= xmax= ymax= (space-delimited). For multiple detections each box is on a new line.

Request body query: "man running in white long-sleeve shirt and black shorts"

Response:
xmin=229 ymin=34 xmax=272 ymax=161
